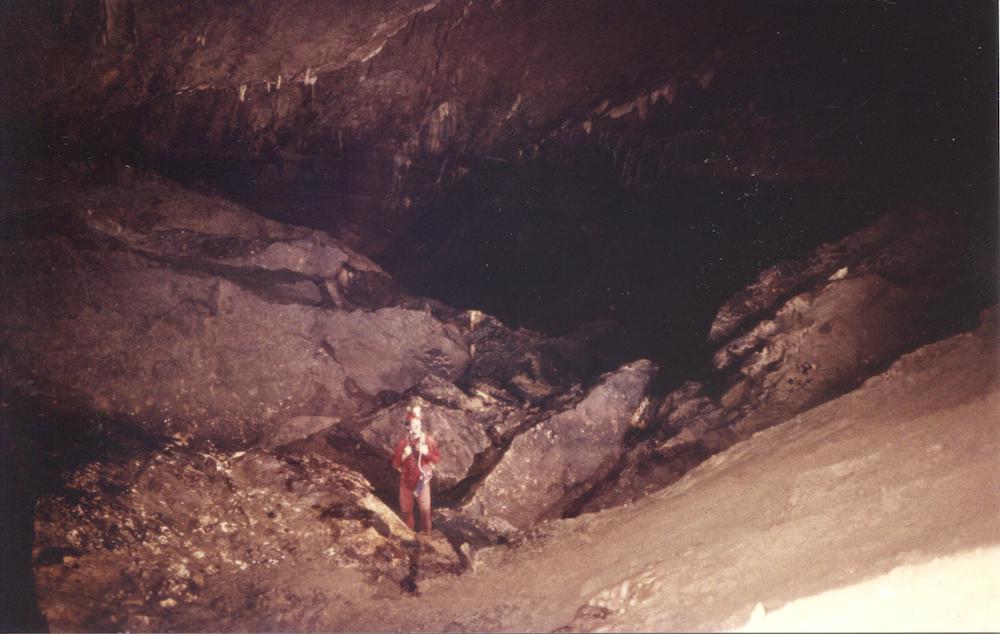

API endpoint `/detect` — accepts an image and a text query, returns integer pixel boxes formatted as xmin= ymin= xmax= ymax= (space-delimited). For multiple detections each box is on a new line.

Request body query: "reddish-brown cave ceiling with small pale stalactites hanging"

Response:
xmin=9 ymin=0 xmax=995 ymax=256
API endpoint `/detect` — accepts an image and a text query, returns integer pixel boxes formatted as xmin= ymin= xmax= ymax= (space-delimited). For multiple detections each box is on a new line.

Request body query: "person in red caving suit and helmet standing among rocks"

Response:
xmin=392 ymin=405 xmax=441 ymax=533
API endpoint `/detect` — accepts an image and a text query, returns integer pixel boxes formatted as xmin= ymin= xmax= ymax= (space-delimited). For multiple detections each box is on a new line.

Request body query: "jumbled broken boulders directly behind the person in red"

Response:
xmin=303 ymin=320 xmax=585 ymax=498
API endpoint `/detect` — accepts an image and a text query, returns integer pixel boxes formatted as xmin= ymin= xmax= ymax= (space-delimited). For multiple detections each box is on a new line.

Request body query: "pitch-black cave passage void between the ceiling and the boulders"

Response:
xmin=145 ymin=149 xmax=997 ymax=385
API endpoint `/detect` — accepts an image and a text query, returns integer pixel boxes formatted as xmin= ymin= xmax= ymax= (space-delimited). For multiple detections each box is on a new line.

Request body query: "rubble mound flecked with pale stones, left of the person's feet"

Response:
xmin=34 ymin=436 xmax=461 ymax=631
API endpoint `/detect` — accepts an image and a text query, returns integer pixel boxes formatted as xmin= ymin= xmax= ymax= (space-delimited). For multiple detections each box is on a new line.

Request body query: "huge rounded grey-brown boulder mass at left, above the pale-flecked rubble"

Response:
xmin=0 ymin=177 xmax=469 ymax=446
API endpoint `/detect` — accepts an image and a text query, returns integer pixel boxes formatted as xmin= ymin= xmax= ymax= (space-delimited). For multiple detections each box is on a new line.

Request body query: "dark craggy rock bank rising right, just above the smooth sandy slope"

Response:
xmin=583 ymin=212 xmax=996 ymax=511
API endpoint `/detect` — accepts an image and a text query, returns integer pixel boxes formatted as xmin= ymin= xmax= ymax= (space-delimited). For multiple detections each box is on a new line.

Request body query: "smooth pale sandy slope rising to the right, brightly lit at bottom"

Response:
xmin=340 ymin=308 xmax=1000 ymax=631
